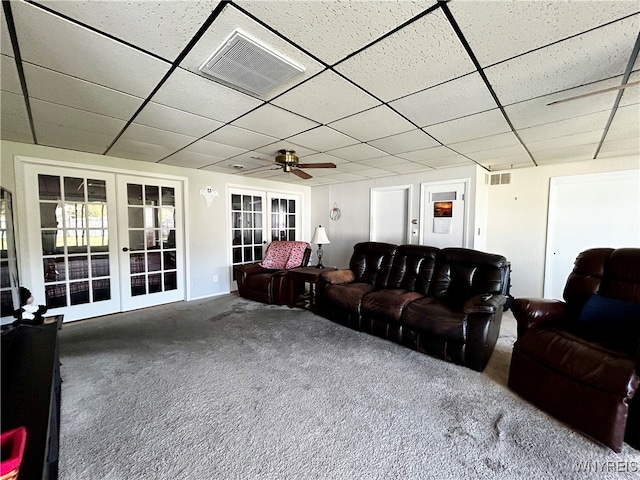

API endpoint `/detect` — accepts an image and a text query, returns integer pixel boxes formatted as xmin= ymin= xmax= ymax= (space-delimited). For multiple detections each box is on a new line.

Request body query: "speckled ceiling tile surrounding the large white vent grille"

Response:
xmin=180 ymin=6 xmax=324 ymax=100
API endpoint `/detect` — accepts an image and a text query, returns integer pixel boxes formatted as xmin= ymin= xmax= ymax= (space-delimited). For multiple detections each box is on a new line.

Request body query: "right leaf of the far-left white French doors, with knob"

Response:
xmin=118 ymin=175 xmax=184 ymax=310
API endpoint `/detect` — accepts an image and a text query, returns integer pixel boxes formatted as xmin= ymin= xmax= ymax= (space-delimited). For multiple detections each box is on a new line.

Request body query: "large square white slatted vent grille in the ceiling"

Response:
xmin=200 ymin=30 xmax=304 ymax=96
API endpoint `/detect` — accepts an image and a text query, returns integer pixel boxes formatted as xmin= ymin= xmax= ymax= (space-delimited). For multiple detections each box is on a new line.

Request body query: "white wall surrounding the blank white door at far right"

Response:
xmin=486 ymin=156 xmax=640 ymax=297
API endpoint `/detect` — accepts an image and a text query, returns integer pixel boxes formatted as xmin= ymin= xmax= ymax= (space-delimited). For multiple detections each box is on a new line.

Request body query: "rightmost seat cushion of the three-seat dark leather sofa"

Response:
xmin=400 ymin=297 xmax=467 ymax=343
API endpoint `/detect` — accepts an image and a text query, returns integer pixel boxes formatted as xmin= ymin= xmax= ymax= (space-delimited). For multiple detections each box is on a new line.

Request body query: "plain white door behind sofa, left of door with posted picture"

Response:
xmin=369 ymin=185 xmax=411 ymax=245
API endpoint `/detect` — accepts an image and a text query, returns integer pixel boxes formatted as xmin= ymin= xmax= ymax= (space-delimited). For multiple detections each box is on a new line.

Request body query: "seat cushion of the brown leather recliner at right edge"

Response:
xmin=516 ymin=328 xmax=638 ymax=397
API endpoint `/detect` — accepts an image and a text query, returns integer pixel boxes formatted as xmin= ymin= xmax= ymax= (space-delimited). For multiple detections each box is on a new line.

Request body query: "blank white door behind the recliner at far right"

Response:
xmin=544 ymin=170 xmax=640 ymax=299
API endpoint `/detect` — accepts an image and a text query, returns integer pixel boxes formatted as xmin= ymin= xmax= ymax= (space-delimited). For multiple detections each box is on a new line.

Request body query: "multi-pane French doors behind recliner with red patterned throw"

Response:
xmin=229 ymin=189 xmax=301 ymax=284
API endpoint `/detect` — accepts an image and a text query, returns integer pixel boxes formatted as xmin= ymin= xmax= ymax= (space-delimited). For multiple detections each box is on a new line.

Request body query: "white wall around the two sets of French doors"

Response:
xmin=0 ymin=141 xmax=311 ymax=298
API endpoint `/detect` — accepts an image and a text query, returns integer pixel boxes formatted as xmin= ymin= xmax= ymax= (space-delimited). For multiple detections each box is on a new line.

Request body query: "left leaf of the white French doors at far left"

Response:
xmin=21 ymin=164 xmax=121 ymax=321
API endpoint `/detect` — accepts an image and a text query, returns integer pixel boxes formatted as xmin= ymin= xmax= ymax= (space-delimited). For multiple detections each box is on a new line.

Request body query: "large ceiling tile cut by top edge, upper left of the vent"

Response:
xmin=39 ymin=0 xmax=218 ymax=61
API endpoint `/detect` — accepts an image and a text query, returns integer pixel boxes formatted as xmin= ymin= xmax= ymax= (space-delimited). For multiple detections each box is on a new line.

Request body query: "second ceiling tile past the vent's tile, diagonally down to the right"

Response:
xmin=329 ymin=105 xmax=415 ymax=142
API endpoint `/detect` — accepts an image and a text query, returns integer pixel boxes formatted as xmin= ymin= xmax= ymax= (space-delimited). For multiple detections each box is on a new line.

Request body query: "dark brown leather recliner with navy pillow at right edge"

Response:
xmin=509 ymin=248 xmax=640 ymax=452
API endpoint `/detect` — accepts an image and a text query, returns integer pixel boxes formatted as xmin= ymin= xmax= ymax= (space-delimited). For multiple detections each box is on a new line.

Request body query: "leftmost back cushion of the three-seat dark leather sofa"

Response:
xmin=349 ymin=242 xmax=398 ymax=289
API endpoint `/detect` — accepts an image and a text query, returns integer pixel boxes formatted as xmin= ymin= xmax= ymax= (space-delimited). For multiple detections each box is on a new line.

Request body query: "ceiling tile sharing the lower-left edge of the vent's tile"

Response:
xmin=152 ymin=69 xmax=263 ymax=122
